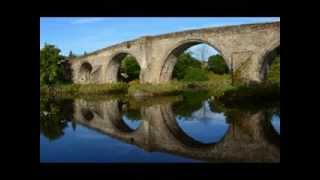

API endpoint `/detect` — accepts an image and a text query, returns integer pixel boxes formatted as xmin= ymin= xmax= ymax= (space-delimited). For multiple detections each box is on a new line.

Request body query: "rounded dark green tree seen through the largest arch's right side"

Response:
xmin=208 ymin=54 xmax=229 ymax=74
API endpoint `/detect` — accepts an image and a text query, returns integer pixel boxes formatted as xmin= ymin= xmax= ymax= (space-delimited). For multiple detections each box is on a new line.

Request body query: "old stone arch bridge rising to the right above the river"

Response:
xmin=67 ymin=22 xmax=280 ymax=84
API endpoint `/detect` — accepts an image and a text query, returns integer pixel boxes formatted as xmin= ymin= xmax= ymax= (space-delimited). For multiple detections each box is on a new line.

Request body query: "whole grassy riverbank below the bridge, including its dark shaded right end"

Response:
xmin=40 ymin=74 xmax=280 ymax=102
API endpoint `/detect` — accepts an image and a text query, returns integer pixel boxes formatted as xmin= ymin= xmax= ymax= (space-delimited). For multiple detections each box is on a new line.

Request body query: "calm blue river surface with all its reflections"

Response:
xmin=40 ymin=93 xmax=280 ymax=163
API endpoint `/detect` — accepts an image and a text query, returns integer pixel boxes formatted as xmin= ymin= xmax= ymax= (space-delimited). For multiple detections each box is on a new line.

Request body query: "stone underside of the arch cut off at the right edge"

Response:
xmin=257 ymin=39 xmax=280 ymax=81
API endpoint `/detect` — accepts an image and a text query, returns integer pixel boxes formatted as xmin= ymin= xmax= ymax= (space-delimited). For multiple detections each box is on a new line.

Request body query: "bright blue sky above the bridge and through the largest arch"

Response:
xmin=40 ymin=17 xmax=280 ymax=59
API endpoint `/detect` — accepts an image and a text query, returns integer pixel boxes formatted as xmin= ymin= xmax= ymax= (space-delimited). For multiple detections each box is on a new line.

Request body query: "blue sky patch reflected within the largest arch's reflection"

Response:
xmin=177 ymin=101 xmax=229 ymax=144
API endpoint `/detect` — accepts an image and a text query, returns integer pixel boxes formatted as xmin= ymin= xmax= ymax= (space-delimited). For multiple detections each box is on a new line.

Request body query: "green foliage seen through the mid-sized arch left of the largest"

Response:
xmin=120 ymin=56 xmax=140 ymax=82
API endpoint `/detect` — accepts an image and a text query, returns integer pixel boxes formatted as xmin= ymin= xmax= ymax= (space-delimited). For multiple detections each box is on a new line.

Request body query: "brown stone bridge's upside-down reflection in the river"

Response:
xmin=53 ymin=95 xmax=280 ymax=162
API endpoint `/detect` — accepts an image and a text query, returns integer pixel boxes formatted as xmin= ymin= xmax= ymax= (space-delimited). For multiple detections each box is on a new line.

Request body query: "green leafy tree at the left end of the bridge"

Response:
xmin=40 ymin=44 xmax=64 ymax=85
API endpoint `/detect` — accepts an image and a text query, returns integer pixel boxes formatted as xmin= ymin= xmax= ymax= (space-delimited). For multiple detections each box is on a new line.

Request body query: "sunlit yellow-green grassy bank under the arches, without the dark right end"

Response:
xmin=40 ymin=74 xmax=232 ymax=97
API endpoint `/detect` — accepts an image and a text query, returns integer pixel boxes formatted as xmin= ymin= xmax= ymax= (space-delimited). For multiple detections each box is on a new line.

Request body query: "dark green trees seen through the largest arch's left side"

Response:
xmin=172 ymin=53 xmax=201 ymax=80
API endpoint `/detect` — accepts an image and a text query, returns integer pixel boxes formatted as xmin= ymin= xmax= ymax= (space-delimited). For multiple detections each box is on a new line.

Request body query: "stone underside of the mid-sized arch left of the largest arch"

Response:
xmin=105 ymin=51 xmax=141 ymax=82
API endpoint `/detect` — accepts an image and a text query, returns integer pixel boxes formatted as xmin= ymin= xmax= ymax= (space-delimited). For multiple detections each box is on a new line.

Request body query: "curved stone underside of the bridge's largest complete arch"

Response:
xmin=159 ymin=39 xmax=229 ymax=83
